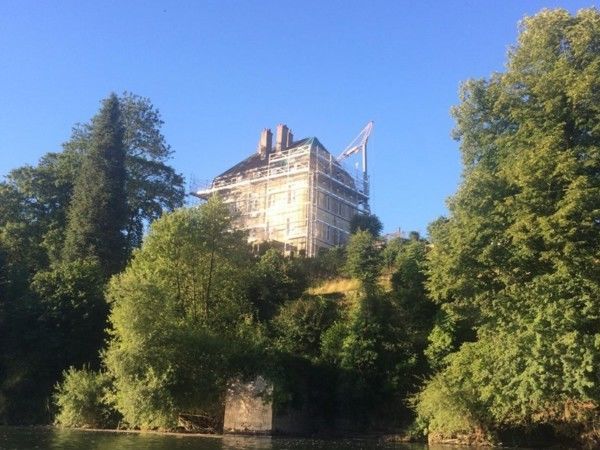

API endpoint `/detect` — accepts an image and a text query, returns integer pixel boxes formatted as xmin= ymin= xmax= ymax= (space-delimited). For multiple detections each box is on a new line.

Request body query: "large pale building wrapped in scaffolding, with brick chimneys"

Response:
xmin=195 ymin=125 xmax=369 ymax=256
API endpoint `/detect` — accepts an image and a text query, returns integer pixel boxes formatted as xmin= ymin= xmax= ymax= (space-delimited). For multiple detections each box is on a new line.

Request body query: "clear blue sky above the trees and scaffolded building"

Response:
xmin=0 ymin=0 xmax=594 ymax=236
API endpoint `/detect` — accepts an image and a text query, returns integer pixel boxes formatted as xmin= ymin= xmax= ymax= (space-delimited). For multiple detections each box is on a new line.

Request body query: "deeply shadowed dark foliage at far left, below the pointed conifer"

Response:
xmin=0 ymin=261 xmax=107 ymax=423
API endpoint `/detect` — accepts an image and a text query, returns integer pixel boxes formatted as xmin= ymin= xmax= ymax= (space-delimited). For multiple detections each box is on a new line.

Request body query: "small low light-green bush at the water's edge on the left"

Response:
xmin=54 ymin=367 xmax=118 ymax=428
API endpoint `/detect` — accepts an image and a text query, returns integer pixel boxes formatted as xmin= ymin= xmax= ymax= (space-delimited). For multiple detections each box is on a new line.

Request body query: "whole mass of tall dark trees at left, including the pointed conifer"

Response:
xmin=0 ymin=93 xmax=183 ymax=423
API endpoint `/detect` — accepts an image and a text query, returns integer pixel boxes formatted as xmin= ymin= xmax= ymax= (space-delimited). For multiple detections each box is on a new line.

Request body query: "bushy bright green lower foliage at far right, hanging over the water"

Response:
xmin=417 ymin=276 xmax=600 ymax=439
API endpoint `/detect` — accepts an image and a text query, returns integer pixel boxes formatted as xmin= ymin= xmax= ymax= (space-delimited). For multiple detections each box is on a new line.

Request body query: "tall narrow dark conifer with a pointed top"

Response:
xmin=63 ymin=94 xmax=127 ymax=276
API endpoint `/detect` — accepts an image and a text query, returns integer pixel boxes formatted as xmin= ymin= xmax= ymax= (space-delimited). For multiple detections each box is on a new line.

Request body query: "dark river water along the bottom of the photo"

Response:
xmin=0 ymin=427 xmax=452 ymax=450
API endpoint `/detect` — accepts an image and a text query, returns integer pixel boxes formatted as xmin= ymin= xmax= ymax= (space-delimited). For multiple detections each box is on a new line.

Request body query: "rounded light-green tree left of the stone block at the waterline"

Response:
xmin=105 ymin=198 xmax=262 ymax=428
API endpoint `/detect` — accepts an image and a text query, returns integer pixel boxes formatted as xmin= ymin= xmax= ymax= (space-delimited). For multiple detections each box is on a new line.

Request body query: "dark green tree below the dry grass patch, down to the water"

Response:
xmin=321 ymin=291 xmax=416 ymax=429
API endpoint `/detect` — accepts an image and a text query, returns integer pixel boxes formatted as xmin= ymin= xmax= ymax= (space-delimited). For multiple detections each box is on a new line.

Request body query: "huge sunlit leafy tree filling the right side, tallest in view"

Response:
xmin=422 ymin=9 xmax=600 ymax=446
